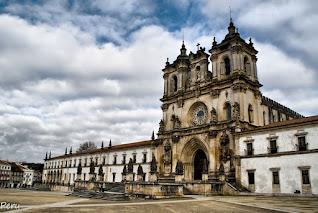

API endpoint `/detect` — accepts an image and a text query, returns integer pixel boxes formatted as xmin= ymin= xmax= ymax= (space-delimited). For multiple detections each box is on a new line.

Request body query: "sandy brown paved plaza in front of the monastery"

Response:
xmin=0 ymin=189 xmax=318 ymax=213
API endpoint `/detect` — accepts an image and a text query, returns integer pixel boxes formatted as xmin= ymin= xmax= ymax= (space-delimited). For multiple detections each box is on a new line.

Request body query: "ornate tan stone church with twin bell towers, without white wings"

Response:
xmin=154 ymin=20 xmax=300 ymax=181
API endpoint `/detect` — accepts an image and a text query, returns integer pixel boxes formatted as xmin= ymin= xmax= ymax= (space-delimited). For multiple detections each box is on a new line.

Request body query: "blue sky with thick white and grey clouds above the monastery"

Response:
xmin=0 ymin=0 xmax=318 ymax=162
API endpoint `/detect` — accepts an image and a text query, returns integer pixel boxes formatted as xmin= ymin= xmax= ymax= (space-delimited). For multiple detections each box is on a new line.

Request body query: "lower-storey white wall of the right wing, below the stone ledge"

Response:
xmin=241 ymin=153 xmax=318 ymax=194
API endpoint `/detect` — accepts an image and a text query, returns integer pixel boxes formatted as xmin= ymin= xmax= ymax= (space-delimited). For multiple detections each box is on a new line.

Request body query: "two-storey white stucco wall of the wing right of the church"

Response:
xmin=239 ymin=123 xmax=318 ymax=194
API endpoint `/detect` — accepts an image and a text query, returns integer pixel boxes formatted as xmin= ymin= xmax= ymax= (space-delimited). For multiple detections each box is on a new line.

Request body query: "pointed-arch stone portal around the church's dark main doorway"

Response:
xmin=180 ymin=137 xmax=209 ymax=181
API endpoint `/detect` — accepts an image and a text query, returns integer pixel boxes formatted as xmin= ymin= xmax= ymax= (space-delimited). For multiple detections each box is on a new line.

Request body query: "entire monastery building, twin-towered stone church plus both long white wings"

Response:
xmin=43 ymin=20 xmax=318 ymax=194
